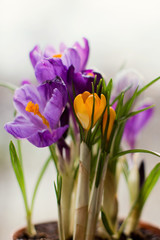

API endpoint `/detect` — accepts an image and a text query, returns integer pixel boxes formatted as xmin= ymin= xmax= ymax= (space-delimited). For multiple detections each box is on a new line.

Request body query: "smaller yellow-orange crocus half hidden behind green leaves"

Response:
xmin=103 ymin=107 xmax=116 ymax=141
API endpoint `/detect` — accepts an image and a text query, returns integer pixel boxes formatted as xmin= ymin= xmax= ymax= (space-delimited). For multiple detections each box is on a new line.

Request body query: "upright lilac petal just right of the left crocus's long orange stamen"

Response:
xmin=43 ymin=88 xmax=63 ymax=129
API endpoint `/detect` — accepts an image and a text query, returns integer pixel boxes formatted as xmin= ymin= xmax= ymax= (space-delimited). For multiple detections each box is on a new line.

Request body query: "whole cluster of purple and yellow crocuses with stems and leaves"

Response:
xmin=5 ymin=38 xmax=160 ymax=240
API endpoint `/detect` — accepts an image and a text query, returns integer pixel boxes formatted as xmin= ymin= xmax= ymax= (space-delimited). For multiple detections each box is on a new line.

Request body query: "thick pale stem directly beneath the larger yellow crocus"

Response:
xmin=73 ymin=142 xmax=91 ymax=240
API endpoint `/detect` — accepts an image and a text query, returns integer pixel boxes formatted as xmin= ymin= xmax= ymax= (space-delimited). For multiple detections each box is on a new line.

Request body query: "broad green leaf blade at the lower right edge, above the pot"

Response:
xmin=137 ymin=163 xmax=160 ymax=210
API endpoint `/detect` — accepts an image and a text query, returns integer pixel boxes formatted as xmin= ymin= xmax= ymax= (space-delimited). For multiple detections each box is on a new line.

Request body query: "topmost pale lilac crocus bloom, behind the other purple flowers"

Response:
xmin=30 ymin=38 xmax=89 ymax=72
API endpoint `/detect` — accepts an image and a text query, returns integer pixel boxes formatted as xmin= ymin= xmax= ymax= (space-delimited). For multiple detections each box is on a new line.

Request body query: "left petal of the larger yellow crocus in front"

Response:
xmin=74 ymin=94 xmax=90 ymax=129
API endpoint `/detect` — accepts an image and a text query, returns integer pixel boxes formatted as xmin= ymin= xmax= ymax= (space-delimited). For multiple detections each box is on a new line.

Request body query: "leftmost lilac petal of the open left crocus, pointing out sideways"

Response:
xmin=4 ymin=116 xmax=38 ymax=139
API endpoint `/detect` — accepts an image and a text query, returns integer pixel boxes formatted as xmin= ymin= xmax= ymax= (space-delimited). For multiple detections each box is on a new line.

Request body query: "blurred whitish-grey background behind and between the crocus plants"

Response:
xmin=0 ymin=0 xmax=160 ymax=240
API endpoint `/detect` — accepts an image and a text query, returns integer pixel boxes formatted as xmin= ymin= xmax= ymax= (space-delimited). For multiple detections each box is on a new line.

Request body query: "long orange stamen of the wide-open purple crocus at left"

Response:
xmin=25 ymin=101 xmax=49 ymax=128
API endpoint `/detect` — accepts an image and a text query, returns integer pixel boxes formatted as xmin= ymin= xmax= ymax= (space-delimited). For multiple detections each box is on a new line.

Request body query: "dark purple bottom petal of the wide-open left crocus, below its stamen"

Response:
xmin=27 ymin=125 xmax=68 ymax=147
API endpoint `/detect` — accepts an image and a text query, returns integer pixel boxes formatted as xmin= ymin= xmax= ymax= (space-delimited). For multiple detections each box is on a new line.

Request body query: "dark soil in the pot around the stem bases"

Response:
xmin=13 ymin=222 xmax=160 ymax=240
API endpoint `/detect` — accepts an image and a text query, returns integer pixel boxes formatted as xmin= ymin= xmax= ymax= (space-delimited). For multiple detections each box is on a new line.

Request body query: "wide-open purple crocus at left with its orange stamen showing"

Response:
xmin=5 ymin=79 xmax=68 ymax=147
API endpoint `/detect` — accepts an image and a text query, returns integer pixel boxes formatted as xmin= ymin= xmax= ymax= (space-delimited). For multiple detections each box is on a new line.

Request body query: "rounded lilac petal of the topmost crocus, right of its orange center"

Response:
xmin=62 ymin=48 xmax=81 ymax=72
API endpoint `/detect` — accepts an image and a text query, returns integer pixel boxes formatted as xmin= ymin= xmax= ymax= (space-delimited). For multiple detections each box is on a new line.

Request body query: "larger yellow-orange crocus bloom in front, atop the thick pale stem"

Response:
xmin=74 ymin=91 xmax=106 ymax=130
